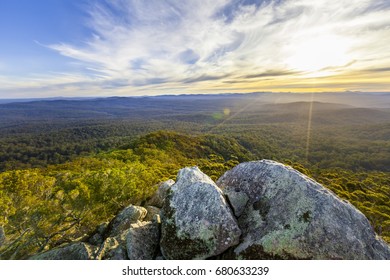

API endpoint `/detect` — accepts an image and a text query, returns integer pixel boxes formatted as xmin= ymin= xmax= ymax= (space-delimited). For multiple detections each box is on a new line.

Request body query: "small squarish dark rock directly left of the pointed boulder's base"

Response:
xmin=126 ymin=221 xmax=160 ymax=260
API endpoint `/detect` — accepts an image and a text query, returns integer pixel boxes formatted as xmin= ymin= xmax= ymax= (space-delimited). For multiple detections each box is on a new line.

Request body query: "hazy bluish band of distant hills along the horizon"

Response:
xmin=0 ymin=92 xmax=390 ymax=124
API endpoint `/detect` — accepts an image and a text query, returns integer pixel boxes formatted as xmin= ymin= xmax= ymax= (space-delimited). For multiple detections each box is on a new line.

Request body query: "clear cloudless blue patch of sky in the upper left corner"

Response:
xmin=0 ymin=0 xmax=85 ymax=73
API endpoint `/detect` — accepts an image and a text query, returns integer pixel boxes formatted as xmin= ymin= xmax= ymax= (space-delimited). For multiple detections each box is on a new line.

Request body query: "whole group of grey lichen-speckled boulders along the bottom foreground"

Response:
xmin=31 ymin=160 xmax=390 ymax=260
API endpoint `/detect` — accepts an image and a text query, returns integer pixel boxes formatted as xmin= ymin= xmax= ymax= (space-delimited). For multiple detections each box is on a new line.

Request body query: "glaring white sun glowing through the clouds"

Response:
xmin=286 ymin=34 xmax=350 ymax=75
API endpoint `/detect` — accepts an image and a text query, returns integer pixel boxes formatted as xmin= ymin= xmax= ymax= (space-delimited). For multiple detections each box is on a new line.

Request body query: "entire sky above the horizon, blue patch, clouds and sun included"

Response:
xmin=0 ymin=0 xmax=390 ymax=99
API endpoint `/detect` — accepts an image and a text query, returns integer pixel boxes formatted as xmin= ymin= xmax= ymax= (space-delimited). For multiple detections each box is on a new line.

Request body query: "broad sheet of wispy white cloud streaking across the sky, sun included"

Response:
xmin=3 ymin=0 xmax=390 ymax=97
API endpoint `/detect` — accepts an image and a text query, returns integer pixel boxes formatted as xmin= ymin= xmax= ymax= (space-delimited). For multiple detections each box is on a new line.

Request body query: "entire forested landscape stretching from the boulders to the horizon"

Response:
xmin=0 ymin=93 xmax=390 ymax=259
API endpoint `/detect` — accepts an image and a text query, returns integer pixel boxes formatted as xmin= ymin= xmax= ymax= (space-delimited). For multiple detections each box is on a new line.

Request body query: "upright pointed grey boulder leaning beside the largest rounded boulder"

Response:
xmin=160 ymin=167 xmax=241 ymax=259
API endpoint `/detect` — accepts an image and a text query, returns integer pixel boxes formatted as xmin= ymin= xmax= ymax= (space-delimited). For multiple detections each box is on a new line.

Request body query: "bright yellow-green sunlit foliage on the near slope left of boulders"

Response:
xmin=0 ymin=132 xmax=245 ymax=258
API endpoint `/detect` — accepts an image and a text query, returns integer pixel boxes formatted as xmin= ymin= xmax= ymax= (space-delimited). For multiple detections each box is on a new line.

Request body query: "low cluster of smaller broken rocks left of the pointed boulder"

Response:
xmin=30 ymin=205 xmax=161 ymax=260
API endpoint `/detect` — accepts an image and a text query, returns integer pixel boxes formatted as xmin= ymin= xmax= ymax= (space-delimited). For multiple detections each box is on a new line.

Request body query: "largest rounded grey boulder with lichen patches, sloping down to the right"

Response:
xmin=217 ymin=160 xmax=390 ymax=259
